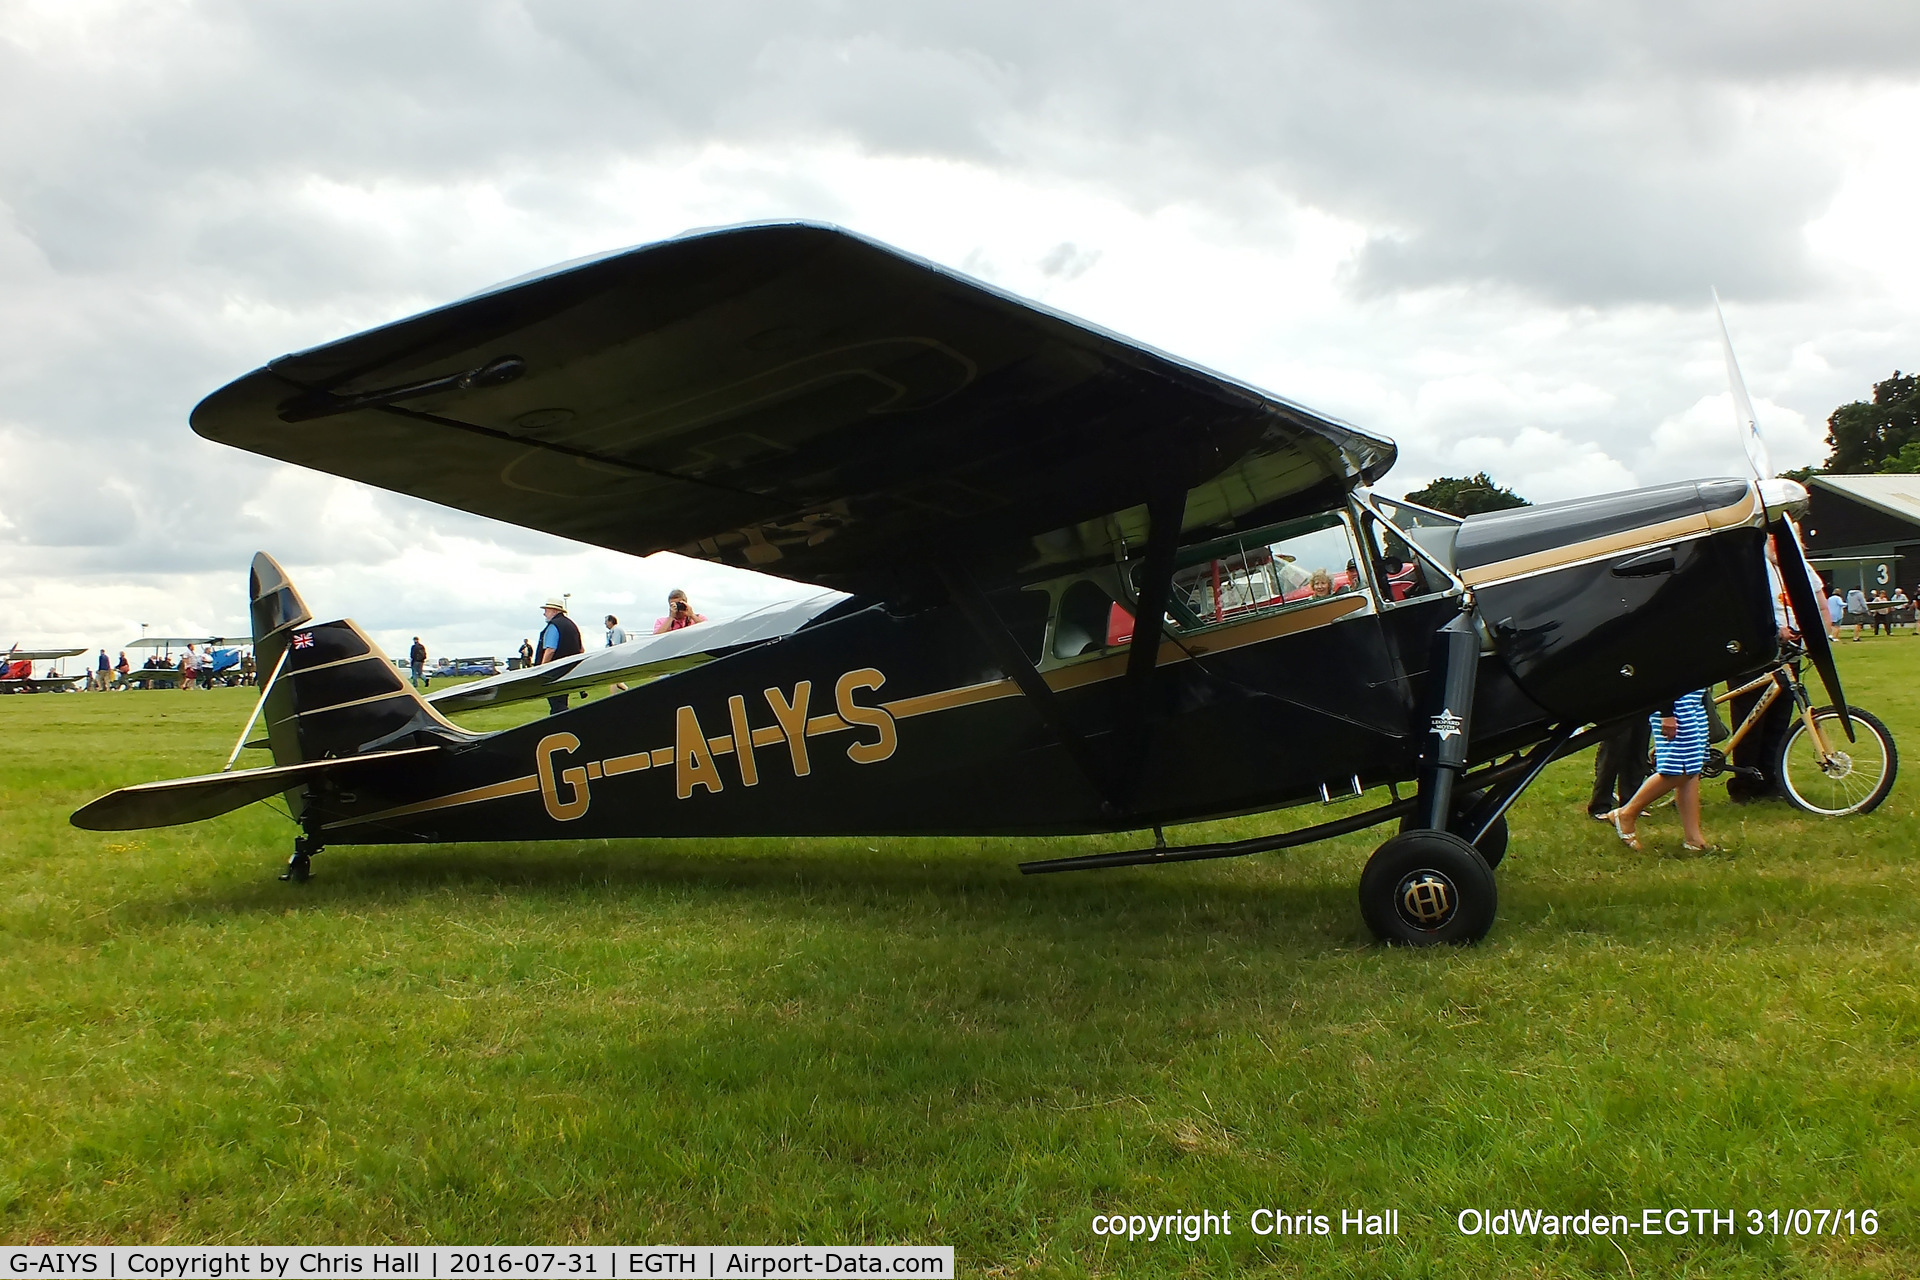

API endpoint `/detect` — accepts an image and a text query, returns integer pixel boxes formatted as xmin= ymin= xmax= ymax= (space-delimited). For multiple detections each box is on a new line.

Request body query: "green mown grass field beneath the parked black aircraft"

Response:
xmin=0 ymin=637 xmax=1920 ymax=1276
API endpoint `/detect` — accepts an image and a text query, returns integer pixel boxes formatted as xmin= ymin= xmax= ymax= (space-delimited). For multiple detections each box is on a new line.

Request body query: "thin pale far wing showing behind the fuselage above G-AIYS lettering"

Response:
xmin=426 ymin=591 xmax=847 ymax=712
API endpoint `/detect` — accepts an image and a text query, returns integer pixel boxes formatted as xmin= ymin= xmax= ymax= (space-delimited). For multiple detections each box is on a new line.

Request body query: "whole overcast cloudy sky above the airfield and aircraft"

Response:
xmin=0 ymin=0 xmax=1920 ymax=652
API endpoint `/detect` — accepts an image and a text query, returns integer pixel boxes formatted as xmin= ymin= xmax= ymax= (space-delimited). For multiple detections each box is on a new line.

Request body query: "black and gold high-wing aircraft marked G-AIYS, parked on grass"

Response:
xmin=73 ymin=223 xmax=1851 ymax=944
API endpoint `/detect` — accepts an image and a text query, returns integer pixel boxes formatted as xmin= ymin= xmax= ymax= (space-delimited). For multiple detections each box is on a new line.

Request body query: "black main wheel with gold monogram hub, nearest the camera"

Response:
xmin=1359 ymin=831 xmax=1500 ymax=946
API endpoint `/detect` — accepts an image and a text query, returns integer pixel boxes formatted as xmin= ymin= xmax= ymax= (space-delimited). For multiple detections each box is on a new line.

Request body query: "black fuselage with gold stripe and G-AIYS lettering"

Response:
xmin=307 ymin=480 xmax=1776 ymax=844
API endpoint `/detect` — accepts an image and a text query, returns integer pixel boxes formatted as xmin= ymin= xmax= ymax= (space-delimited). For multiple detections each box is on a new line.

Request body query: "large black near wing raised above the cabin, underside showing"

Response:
xmin=192 ymin=223 xmax=1394 ymax=595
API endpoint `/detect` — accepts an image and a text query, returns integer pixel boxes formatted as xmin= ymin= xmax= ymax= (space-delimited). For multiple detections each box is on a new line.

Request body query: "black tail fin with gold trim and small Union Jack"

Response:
xmin=248 ymin=551 xmax=472 ymax=768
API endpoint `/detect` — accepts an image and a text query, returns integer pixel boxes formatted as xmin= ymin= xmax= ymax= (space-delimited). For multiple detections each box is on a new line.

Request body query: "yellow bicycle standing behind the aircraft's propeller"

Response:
xmin=1701 ymin=651 xmax=1901 ymax=818
